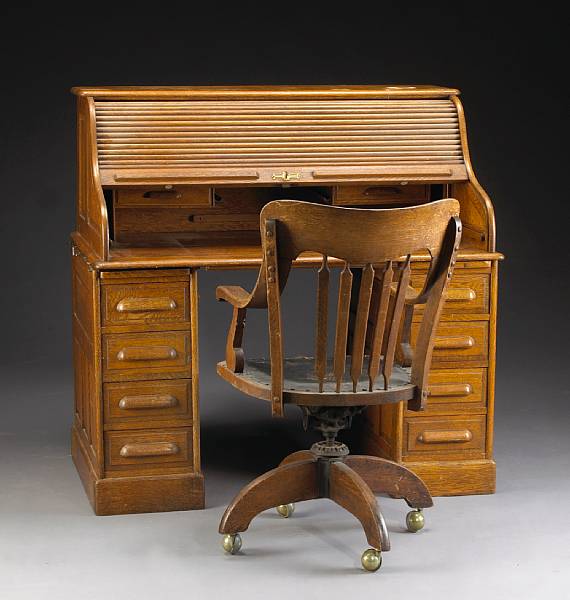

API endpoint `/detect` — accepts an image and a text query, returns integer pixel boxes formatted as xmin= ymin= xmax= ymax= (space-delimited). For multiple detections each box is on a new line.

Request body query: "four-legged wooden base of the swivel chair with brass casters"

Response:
xmin=219 ymin=450 xmax=433 ymax=571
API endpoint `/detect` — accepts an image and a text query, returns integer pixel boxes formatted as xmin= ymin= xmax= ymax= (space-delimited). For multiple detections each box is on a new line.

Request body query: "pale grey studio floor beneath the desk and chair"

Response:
xmin=0 ymin=370 xmax=570 ymax=600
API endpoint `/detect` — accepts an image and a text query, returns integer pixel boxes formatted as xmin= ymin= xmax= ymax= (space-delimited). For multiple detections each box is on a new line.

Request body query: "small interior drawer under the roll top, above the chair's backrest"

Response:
xmin=333 ymin=184 xmax=429 ymax=206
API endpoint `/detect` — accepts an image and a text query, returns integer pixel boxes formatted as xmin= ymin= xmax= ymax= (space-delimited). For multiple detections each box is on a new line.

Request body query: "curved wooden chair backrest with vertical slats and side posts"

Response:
xmin=254 ymin=199 xmax=461 ymax=415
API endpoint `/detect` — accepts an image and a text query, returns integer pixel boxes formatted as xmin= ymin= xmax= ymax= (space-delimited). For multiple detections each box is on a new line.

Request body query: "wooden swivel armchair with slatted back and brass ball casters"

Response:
xmin=216 ymin=199 xmax=461 ymax=571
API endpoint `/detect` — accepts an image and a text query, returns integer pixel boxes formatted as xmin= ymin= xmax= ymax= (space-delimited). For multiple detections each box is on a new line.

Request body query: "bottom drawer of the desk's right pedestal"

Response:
xmin=403 ymin=415 xmax=486 ymax=460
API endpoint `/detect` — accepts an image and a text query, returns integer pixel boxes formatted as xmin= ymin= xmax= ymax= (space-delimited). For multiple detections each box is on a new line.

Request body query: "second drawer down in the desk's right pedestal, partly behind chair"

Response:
xmin=412 ymin=321 xmax=489 ymax=366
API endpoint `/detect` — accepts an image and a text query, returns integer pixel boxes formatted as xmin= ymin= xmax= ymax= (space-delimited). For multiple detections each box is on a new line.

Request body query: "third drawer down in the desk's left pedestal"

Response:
xmin=103 ymin=379 xmax=192 ymax=427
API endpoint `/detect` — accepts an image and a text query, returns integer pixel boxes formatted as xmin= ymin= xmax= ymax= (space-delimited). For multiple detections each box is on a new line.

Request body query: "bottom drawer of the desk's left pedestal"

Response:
xmin=105 ymin=427 xmax=192 ymax=469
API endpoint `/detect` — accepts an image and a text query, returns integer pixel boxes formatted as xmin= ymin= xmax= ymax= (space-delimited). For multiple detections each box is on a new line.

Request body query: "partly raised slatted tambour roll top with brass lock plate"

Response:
xmin=74 ymin=86 xmax=467 ymax=186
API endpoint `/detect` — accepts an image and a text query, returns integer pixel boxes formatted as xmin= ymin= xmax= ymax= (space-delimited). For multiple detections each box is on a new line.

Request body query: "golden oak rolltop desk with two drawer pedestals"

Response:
xmin=72 ymin=86 xmax=501 ymax=514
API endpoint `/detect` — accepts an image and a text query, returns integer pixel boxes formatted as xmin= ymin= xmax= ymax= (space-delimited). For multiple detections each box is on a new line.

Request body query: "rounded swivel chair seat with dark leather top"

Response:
xmin=217 ymin=356 xmax=416 ymax=406
